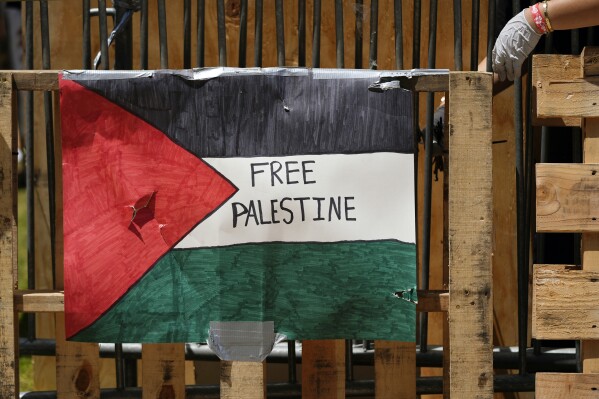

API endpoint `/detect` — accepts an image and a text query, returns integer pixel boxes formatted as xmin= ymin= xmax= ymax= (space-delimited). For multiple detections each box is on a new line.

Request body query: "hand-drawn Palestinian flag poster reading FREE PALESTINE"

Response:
xmin=60 ymin=69 xmax=416 ymax=342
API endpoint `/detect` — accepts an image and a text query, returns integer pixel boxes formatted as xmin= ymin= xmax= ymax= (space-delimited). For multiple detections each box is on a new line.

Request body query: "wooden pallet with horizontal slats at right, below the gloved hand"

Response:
xmin=532 ymin=48 xmax=599 ymax=399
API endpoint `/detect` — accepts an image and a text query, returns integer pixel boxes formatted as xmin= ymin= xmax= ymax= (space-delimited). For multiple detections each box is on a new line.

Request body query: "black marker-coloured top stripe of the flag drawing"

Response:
xmin=74 ymin=73 xmax=414 ymax=157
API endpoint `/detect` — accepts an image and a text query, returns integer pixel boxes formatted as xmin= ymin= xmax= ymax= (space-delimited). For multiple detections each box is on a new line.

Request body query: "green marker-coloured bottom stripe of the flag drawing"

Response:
xmin=73 ymin=241 xmax=416 ymax=342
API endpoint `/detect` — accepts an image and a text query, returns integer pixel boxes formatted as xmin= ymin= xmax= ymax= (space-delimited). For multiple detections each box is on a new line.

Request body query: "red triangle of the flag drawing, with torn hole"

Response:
xmin=60 ymin=79 xmax=237 ymax=339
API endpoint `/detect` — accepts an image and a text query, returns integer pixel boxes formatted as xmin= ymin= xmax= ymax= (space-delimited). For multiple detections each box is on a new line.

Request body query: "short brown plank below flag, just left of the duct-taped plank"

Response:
xmin=141 ymin=344 xmax=185 ymax=399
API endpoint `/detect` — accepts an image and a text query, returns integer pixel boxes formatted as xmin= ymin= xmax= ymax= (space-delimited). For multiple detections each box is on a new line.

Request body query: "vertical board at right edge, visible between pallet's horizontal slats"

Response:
xmin=580 ymin=114 xmax=599 ymax=373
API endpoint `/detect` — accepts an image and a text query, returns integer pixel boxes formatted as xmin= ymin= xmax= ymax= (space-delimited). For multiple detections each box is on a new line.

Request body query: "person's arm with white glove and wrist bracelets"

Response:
xmin=493 ymin=0 xmax=599 ymax=80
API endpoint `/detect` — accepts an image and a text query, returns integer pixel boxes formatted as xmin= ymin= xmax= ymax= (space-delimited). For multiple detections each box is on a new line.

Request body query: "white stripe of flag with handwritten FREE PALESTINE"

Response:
xmin=176 ymin=153 xmax=416 ymax=248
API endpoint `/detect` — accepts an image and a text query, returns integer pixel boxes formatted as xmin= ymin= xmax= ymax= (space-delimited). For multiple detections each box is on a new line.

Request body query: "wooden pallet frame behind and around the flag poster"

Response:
xmin=0 ymin=71 xmax=493 ymax=399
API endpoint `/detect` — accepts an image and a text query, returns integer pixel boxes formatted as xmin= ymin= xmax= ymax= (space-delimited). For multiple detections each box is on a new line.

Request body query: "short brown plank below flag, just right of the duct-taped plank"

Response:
xmin=302 ymin=339 xmax=345 ymax=399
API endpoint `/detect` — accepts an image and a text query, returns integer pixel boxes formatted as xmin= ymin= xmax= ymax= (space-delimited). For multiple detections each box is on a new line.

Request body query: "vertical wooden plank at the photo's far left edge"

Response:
xmin=0 ymin=73 xmax=19 ymax=399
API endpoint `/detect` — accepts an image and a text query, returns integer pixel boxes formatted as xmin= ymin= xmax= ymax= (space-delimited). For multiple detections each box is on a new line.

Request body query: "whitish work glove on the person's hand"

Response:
xmin=493 ymin=11 xmax=541 ymax=81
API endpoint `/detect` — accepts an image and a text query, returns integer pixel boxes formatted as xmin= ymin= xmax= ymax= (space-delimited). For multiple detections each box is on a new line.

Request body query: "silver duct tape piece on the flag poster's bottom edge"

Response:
xmin=208 ymin=321 xmax=286 ymax=362
